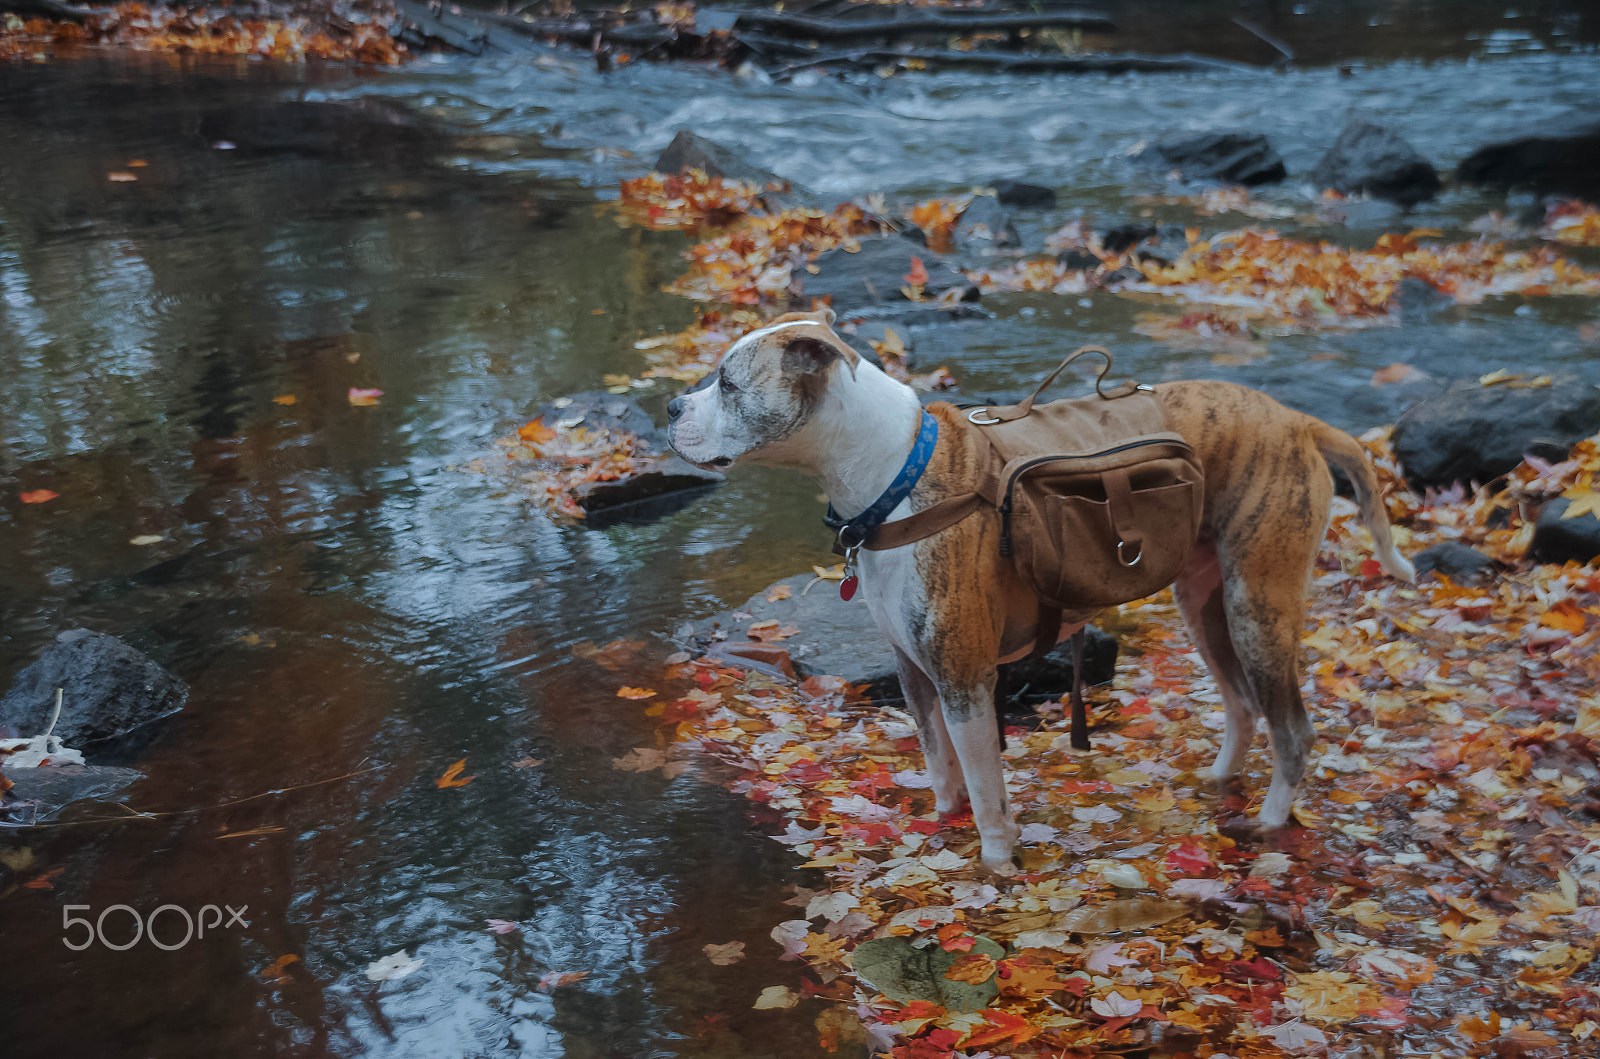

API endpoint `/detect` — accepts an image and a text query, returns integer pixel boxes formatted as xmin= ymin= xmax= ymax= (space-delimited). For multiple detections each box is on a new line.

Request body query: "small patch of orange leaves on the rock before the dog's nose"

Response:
xmin=464 ymin=419 xmax=658 ymax=518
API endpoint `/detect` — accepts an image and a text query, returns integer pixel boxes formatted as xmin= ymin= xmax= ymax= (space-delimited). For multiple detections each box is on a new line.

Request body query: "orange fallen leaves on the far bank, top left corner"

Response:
xmin=0 ymin=0 xmax=406 ymax=66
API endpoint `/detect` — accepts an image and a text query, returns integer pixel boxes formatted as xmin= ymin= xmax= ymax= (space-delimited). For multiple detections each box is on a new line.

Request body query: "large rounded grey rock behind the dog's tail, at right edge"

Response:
xmin=1394 ymin=379 xmax=1600 ymax=490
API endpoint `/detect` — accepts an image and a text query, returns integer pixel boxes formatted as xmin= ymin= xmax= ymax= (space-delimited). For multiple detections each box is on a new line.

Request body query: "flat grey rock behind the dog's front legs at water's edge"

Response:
xmin=699 ymin=574 xmax=1117 ymax=702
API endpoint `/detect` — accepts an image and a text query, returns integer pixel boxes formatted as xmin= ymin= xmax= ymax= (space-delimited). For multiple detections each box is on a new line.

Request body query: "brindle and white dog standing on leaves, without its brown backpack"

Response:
xmin=667 ymin=309 xmax=1413 ymax=873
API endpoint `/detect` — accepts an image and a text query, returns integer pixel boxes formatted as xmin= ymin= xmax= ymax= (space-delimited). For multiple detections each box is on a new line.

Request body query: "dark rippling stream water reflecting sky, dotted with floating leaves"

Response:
xmin=0 ymin=5 xmax=1600 ymax=1056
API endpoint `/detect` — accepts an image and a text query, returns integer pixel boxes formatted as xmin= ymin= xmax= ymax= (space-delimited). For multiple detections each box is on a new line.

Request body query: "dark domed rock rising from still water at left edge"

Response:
xmin=0 ymin=629 xmax=189 ymax=755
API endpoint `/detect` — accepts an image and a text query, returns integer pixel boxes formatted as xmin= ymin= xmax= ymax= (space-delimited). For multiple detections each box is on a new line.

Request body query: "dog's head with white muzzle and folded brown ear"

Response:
xmin=667 ymin=307 xmax=861 ymax=467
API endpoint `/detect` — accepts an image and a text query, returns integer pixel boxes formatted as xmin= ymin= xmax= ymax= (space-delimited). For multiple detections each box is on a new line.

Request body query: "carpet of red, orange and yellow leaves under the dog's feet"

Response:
xmin=592 ymin=432 xmax=1600 ymax=1059
